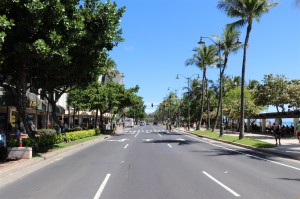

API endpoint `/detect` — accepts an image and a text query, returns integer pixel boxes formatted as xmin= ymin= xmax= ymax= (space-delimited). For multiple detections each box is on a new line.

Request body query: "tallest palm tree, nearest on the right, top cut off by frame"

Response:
xmin=218 ymin=0 xmax=278 ymax=139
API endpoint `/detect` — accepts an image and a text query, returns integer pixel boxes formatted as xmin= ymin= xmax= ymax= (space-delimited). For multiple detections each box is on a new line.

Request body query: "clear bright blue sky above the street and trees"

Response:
xmin=110 ymin=0 xmax=300 ymax=113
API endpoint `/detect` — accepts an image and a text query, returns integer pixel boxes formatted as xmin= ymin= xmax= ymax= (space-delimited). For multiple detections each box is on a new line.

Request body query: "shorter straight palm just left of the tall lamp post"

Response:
xmin=185 ymin=45 xmax=218 ymax=129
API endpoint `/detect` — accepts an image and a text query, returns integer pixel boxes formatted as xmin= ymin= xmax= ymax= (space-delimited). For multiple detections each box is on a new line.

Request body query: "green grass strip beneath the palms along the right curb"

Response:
xmin=193 ymin=130 xmax=276 ymax=148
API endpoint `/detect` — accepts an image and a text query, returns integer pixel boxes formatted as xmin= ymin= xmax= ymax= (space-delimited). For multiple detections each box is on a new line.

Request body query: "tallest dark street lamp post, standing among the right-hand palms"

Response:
xmin=198 ymin=37 xmax=224 ymax=136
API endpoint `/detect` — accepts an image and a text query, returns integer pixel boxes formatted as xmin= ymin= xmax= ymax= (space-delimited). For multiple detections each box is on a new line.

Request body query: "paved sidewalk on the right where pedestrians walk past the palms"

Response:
xmin=179 ymin=128 xmax=300 ymax=160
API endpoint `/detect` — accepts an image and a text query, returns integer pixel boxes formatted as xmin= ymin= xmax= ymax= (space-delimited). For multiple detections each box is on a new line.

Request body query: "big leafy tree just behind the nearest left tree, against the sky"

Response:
xmin=36 ymin=0 xmax=125 ymax=132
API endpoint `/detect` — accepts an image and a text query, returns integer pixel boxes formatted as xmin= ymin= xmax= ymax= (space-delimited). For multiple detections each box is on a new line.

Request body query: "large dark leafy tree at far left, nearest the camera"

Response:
xmin=0 ymin=0 xmax=82 ymax=137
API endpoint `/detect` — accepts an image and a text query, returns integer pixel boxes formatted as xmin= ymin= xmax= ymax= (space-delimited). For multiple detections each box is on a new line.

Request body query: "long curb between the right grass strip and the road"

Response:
xmin=177 ymin=129 xmax=300 ymax=161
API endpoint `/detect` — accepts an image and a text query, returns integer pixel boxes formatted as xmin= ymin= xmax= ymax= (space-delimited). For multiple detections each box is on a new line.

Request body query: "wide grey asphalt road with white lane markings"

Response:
xmin=0 ymin=125 xmax=300 ymax=199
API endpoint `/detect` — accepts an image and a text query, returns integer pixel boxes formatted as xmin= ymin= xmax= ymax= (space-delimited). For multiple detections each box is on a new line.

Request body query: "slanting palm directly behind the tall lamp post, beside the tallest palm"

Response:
xmin=212 ymin=26 xmax=241 ymax=131
